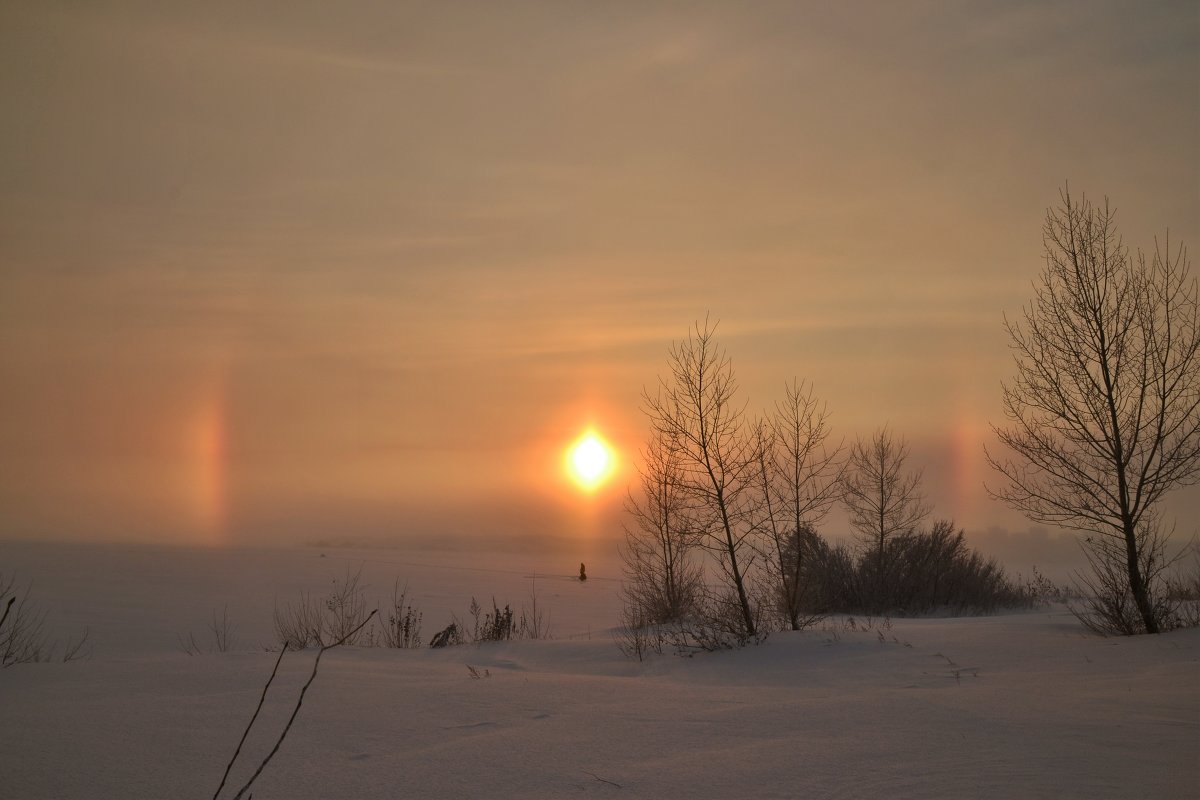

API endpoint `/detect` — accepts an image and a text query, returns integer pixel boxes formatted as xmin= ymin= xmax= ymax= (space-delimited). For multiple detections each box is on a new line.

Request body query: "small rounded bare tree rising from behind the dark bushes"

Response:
xmin=842 ymin=427 xmax=930 ymax=570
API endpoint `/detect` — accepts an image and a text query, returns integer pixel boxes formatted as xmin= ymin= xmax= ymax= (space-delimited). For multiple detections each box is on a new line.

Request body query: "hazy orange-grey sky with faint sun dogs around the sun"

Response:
xmin=0 ymin=0 xmax=1200 ymax=554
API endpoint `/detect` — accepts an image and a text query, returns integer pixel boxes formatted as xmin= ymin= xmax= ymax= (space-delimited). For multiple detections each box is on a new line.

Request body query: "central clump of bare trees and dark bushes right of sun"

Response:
xmin=622 ymin=321 xmax=1022 ymax=649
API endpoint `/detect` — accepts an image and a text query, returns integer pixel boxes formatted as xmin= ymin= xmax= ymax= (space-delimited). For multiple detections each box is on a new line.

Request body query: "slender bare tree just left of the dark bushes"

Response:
xmin=755 ymin=379 xmax=845 ymax=631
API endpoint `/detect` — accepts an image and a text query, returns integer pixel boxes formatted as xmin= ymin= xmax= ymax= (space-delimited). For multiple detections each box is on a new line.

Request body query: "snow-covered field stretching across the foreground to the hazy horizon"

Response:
xmin=0 ymin=542 xmax=1200 ymax=800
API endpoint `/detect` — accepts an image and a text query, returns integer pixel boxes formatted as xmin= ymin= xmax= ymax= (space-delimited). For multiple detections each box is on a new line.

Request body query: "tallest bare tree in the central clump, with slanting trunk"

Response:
xmin=642 ymin=320 xmax=757 ymax=637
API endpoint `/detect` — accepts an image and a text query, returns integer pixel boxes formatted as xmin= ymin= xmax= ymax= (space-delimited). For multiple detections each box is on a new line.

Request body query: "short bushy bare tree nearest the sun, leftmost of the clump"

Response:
xmin=620 ymin=434 xmax=703 ymax=628
